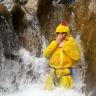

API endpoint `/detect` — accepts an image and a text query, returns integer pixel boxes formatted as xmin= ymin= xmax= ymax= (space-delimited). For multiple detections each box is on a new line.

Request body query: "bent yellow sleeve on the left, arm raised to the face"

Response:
xmin=43 ymin=41 xmax=58 ymax=58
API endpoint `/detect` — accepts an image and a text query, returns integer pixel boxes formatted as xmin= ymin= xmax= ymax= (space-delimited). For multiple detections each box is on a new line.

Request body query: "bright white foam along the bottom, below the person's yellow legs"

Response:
xmin=0 ymin=84 xmax=85 ymax=96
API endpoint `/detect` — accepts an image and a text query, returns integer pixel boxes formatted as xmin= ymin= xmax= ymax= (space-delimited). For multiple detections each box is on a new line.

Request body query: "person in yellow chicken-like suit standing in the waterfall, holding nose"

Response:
xmin=43 ymin=22 xmax=80 ymax=90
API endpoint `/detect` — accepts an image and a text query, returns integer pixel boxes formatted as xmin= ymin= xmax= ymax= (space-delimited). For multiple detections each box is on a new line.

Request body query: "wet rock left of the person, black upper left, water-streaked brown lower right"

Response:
xmin=11 ymin=4 xmax=41 ymax=57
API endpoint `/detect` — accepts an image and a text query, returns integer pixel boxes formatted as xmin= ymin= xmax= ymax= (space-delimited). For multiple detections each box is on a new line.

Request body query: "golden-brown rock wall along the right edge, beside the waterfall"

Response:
xmin=81 ymin=14 xmax=96 ymax=96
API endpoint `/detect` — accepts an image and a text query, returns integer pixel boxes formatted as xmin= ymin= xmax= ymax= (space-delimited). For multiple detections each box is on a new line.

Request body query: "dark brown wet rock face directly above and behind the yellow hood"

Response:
xmin=37 ymin=2 xmax=71 ymax=42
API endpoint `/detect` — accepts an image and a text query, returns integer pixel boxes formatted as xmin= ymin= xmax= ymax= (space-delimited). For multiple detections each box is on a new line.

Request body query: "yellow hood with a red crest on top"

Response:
xmin=56 ymin=22 xmax=70 ymax=37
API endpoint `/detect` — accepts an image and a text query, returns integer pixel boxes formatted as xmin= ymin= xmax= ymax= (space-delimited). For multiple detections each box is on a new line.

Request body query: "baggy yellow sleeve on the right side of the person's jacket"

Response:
xmin=63 ymin=37 xmax=80 ymax=61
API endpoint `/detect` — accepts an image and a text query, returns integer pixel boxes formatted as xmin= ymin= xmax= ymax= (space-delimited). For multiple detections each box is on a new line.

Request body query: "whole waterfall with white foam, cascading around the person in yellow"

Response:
xmin=0 ymin=0 xmax=90 ymax=96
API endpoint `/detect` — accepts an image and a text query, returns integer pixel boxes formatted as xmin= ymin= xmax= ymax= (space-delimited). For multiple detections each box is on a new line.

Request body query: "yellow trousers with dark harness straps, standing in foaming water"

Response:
xmin=44 ymin=68 xmax=72 ymax=90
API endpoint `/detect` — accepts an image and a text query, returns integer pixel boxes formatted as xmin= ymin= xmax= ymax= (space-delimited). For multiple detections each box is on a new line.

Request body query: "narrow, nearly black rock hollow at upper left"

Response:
xmin=11 ymin=4 xmax=25 ymax=40
